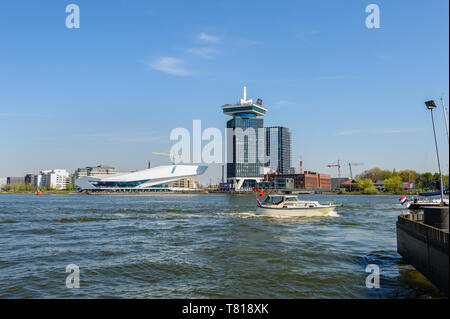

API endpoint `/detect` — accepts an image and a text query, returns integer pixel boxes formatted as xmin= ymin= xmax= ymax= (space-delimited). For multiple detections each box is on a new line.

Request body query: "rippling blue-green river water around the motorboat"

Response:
xmin=0 ymin=194 xmax=443 ymax=298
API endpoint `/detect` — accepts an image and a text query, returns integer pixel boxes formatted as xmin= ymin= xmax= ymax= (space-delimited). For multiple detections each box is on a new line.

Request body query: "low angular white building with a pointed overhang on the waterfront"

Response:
xmin=75 ymin=165 xmax=208 ymax=191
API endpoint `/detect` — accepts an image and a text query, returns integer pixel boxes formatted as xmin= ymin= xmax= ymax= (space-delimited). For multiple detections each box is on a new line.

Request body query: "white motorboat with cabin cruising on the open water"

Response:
xmin=256 ymin=195 xmax=339 ymax=217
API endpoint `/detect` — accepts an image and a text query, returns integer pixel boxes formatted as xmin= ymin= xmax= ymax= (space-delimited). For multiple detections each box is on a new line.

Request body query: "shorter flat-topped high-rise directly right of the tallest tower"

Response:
xmin=264 ymin=126 xmax=294 ymax=174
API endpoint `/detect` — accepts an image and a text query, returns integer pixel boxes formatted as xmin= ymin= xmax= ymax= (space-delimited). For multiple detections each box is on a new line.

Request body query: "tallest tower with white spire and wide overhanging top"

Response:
xmin=222 ymin=86 xmax=267 ymax=189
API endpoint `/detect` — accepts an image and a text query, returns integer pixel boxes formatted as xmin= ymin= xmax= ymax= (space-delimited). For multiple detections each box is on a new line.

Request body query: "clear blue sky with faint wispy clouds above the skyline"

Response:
xmin=0 ymin=0 xmax=449 ymax=183
